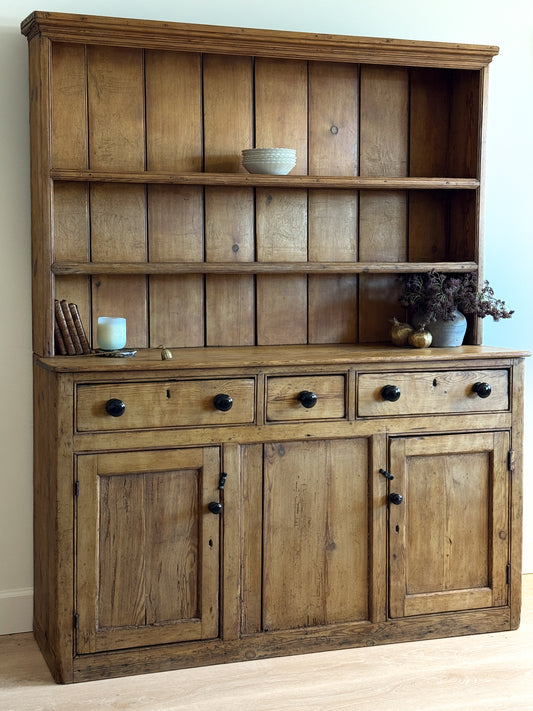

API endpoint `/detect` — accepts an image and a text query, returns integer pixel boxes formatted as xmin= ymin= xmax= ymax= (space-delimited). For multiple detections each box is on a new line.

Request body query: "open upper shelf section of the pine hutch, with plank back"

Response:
xmin=22 ymin=12 xmax=498 ymax=356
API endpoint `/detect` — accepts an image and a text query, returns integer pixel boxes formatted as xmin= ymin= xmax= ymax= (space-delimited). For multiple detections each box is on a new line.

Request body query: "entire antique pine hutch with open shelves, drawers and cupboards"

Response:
xmin=22 ymin=12 xmax=526 ymax=682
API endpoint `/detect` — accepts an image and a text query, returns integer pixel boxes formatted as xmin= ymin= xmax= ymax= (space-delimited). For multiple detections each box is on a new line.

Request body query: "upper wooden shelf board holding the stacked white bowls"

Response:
xmin=50 ymin=170 xmax=479 ymax=190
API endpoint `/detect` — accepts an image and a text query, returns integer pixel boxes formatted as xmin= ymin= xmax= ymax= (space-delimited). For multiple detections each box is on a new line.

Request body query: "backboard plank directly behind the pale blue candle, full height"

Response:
xmin=87 ymin=46 xmax=148 ymax=347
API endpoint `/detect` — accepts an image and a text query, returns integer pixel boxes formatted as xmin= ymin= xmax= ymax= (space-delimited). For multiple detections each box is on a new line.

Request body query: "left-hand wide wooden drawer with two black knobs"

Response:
xmin=76 ymin=378 xmax=255 ymax=432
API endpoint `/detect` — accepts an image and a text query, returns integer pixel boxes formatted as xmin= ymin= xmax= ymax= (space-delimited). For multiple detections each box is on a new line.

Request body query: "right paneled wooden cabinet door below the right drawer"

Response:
xmin=389 ymin=432 xmax=509 ymax=617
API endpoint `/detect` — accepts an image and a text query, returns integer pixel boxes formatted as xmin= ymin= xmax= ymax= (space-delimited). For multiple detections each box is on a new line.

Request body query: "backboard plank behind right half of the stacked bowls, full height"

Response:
xmin=255 ymin=58 xmax=307 ymax=345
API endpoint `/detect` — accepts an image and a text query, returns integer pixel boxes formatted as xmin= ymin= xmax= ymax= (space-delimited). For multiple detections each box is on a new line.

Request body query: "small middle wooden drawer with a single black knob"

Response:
xmin=266 ymin=375 xmax=346 ymax=422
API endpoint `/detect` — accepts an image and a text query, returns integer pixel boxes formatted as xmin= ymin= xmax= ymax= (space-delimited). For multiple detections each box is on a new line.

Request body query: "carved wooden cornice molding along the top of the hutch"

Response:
xmin=21 ymin=11 xmax=499 ymax=69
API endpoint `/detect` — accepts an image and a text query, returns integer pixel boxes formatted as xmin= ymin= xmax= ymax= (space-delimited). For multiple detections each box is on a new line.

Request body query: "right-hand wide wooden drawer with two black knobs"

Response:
xmin=357 ymin=370 xmax=509 ymax=417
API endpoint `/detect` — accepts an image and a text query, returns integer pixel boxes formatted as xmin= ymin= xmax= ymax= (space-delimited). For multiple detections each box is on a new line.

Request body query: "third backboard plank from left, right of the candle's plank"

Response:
xmin=145 ymin=51 xmax=204 ymax=347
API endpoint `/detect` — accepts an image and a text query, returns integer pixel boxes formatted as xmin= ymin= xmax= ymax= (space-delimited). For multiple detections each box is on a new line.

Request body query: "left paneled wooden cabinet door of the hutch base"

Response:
xmin=76 ymin=447 xmax=220 ymax=654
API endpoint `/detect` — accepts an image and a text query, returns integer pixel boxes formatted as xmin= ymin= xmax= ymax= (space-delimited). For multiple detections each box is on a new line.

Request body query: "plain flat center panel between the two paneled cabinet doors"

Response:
xmin=262 ymin=438 xmax=370 ymax=631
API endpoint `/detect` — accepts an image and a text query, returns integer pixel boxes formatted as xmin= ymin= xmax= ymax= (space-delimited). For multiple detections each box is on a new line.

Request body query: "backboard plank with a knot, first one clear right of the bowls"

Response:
xmin=308 ymin=62 xmax=359 ymax=343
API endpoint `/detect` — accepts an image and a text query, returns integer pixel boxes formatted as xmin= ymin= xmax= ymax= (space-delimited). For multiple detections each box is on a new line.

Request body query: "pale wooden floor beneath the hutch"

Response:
xmin=0 ymin=575 xmax=533 ymax=711
